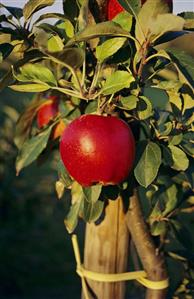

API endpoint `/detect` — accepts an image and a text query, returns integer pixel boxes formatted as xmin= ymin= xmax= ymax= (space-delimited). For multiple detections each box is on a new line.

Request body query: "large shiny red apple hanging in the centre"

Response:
xmin=60 ymin=114 xmax=135 ymax=186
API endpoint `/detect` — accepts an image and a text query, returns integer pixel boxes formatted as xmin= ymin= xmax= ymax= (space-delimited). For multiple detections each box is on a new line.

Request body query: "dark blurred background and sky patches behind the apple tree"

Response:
xmin=0 ymin=0 xmax=194 ymax=299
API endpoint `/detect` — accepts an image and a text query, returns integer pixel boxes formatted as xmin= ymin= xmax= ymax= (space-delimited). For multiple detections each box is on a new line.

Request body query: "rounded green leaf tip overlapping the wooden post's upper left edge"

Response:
xmin=82 ymin=198 xmax=104 ymax=223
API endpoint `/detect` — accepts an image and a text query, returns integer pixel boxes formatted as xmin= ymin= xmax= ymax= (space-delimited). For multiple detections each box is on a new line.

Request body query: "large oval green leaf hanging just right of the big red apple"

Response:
xmin=134 ymin=142 xmax=161 ymax=188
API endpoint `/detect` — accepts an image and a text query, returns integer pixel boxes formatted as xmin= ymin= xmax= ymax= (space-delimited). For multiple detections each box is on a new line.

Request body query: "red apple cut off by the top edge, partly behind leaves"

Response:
xmin=107 ymin=0 xmax=173 ymax=20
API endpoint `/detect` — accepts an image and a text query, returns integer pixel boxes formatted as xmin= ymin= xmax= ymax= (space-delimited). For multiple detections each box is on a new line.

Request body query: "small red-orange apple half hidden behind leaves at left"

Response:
xmin=37 ymin=96 xmax=66 ymax=139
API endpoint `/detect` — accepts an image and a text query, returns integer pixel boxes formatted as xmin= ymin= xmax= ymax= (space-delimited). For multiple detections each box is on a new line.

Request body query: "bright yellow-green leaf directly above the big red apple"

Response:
xmin=102 ymin=71 xmax=135 ymax=95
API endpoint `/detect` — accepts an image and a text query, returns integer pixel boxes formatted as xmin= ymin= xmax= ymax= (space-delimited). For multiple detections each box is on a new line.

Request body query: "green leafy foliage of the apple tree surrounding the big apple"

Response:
xmin=0 ymin=0 xmax=194 ymax=296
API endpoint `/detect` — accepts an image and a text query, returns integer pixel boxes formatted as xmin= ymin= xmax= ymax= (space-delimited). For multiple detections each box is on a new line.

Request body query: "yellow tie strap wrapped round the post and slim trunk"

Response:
xmin=72 ymin=235 xmax=169 ymax=299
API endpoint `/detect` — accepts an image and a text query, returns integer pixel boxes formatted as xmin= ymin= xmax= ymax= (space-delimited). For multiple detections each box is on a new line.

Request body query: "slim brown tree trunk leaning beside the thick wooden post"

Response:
xmin=126 ymin=190 xmax=168 ymax=299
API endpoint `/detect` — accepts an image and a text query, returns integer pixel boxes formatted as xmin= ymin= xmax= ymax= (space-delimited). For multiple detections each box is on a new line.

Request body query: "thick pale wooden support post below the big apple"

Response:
xmin=84 ymin=198 xmax=129 ymax=299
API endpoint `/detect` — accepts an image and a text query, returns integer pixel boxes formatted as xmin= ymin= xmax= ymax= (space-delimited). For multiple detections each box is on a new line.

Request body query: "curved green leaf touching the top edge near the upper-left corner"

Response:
xmin=23 ymin=0 xmax=55 ymax=20
